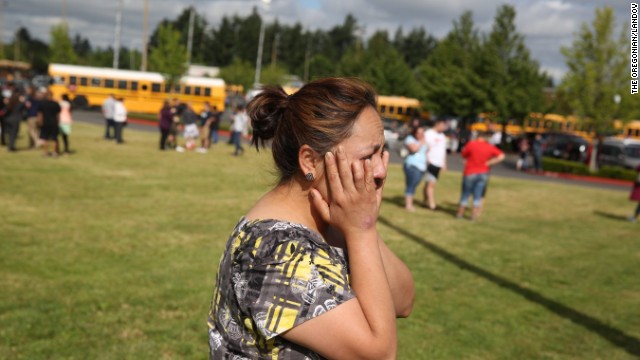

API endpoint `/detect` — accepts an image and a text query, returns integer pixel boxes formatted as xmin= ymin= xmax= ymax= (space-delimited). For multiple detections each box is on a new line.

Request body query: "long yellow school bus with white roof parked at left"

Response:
xmin=49 ymin=64 xmax=225 ymax=114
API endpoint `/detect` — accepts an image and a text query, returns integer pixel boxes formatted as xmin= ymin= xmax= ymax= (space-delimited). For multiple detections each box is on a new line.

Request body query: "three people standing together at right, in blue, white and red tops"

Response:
xmin=403 ymin=119 xmax=505 ymax=220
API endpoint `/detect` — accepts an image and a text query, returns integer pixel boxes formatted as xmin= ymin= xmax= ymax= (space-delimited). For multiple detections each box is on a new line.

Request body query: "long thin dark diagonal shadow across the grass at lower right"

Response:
xmin=378 ymin=217 xmax=640 ymax=356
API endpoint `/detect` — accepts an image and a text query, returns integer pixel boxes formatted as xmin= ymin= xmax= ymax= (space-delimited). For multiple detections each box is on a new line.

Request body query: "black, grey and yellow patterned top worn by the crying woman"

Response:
xmin=207 ymin=218 xmax=355 ymax=360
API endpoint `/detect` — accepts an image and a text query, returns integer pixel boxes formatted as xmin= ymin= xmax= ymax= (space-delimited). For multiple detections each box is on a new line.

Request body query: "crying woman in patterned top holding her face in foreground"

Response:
xmin=208 ymin=78 xmax=414 ymax=359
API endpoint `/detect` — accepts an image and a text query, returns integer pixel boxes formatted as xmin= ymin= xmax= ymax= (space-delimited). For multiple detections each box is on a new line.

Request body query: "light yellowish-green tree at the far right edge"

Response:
xmin=560 ymin=7 xmax=638 ymax=133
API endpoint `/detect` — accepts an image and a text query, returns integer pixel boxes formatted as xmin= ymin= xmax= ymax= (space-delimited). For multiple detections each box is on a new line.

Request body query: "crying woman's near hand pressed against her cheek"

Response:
xmin=311 ymin=147 xmax=380 ymax=239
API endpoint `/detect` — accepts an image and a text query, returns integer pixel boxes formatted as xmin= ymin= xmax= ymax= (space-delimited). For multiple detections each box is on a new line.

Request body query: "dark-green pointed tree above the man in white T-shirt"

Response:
xmin=417 ymin=11 xmax=489 ymax=119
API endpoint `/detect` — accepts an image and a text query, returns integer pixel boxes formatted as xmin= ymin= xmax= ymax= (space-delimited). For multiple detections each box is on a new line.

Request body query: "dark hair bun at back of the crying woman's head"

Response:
xmin=247 ymin=86 xmax=289 ymax=147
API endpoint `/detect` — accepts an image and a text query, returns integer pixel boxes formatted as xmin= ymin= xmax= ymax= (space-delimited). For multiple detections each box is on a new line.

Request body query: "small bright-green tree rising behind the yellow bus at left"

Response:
xmin=149 ymin=25 xmax=187 ymax=88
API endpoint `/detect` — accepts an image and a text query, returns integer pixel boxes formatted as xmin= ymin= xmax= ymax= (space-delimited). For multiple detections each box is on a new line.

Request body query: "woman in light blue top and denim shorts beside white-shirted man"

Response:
xmin=404 ymin=126 xmax=427 ymax=211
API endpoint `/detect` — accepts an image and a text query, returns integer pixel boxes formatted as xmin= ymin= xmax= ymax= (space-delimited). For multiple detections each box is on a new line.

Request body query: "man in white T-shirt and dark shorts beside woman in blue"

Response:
xmin=422 ymin=119 xmax=447 ymax=210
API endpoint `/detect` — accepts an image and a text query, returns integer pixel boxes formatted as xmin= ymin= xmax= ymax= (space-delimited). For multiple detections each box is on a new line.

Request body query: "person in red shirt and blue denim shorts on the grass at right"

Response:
xmin=456 ymin=133 xmax=504 ymax=220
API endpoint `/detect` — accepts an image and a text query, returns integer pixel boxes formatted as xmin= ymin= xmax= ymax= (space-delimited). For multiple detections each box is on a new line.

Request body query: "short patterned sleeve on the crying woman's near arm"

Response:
xmin=233 ymin=231 xmax=355 ymax=339
